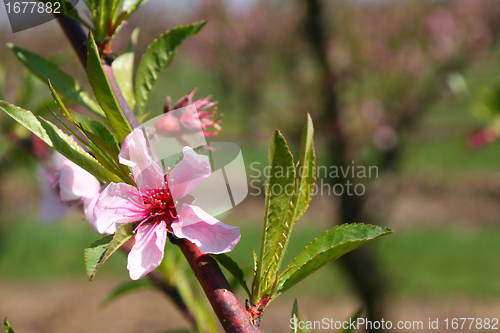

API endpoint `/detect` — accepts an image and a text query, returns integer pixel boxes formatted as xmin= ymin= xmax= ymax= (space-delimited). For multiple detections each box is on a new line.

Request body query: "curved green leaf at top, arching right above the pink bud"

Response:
xmin=135 ymin=21 xmax=206 ymax=115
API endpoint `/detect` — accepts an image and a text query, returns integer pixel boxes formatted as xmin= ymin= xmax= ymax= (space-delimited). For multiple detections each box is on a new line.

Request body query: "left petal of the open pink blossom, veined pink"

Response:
xmin=94 ymin=183 xmax=147 ymax=234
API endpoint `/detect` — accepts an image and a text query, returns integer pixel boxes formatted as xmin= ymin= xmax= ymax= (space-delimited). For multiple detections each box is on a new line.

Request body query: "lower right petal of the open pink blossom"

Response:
xmin=172 ymin=204 xmax=241 ymax=254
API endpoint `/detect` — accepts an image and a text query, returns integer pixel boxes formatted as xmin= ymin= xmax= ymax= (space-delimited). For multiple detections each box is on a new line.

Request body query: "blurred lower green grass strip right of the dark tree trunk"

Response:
xmin=374 ymin=227 xmax=500 ymax=298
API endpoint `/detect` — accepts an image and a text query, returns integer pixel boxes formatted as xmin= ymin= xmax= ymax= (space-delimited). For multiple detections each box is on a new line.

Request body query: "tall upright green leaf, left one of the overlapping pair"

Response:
xmin=252 ymin=130 xmax=295 ymax=303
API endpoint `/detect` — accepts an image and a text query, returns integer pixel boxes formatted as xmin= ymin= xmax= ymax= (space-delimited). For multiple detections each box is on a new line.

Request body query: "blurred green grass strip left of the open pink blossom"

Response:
xmin=0 ymin=216 xmax=127 ymax=281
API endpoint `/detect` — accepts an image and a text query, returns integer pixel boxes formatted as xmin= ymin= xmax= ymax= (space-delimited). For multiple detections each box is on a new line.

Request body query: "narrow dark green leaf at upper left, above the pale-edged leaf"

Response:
xmin=7 ymin=43 xmax=105 ymax=117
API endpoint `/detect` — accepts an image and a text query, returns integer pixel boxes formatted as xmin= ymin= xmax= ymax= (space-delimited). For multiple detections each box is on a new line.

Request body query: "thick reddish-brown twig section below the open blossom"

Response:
xmin=169 ymin=234 xmax=260 ymax=333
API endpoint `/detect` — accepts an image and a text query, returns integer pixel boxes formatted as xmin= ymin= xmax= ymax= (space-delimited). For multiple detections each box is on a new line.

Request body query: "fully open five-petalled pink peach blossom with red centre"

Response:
xmin=94 ymin=129 xmax=240 ymax=280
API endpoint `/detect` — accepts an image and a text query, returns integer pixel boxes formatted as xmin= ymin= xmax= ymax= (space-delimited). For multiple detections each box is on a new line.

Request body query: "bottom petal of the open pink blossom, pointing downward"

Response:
xmin=127 ymin=221 xmax=167 ymax=280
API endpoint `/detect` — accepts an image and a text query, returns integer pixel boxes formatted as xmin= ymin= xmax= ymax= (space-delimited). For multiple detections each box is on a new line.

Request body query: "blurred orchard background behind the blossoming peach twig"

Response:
xmin=0 ymin=0 xmax=500 ymax=332
